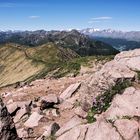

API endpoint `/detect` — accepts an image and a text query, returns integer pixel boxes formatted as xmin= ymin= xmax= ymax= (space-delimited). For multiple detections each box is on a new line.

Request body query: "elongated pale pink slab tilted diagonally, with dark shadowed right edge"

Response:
xmin=60 ymin=83 xmax=81 ymax=100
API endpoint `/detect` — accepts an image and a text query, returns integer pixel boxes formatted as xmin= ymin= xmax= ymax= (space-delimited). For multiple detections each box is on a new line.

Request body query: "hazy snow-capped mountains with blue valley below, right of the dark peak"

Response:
xmin=80 ymin=28 xmax=140 ymax=51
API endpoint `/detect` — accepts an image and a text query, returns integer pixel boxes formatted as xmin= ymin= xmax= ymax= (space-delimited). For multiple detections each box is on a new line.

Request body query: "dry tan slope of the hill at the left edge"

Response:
xmin=0 ymin=44 xmax=43 ymax=87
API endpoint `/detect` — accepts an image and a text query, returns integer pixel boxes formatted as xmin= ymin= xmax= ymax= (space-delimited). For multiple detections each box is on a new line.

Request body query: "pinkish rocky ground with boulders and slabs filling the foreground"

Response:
xmin=0 ymin=49 xmax=140 ymax=140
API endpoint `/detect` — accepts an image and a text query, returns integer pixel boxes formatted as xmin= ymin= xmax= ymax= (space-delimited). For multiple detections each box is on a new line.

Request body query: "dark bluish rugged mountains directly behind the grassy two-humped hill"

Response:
xmin=0 ymin=30 xmax=119 ymax=56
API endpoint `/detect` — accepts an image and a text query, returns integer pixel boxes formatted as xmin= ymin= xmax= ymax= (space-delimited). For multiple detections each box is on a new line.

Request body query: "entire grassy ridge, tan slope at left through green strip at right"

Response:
xmin=0 ymin=43 xmax=113 ymax=87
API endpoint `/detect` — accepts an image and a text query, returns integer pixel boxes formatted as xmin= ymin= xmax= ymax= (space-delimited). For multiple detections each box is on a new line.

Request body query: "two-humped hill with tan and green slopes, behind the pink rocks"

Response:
xmin=0 ymin=43 xmax=78 ymax=86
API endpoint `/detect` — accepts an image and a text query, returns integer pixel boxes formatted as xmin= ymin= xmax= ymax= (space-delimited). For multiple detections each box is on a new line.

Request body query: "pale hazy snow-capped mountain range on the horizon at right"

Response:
xmin=81 ymin=28 xmax=140 ymax=42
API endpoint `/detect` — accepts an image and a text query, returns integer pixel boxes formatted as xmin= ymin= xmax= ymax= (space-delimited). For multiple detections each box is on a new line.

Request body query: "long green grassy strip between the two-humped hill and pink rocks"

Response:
xmin=20 ymin=55 xmax=114 ymax=82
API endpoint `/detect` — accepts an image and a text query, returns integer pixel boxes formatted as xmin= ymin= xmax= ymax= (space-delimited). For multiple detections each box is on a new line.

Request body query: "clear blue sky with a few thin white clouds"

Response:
xmin=0 ymin=0 xmax=140 ymax=31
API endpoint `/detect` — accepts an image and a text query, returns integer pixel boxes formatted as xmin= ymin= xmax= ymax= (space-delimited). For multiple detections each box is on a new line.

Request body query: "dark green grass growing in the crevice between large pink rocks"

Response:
xmin=87 ymin=80 xmax=132 ymax=122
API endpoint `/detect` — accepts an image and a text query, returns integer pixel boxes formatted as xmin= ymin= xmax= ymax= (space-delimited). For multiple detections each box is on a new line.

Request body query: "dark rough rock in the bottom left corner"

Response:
xmin=0 ymin=98 xmax=20 ymax=140
